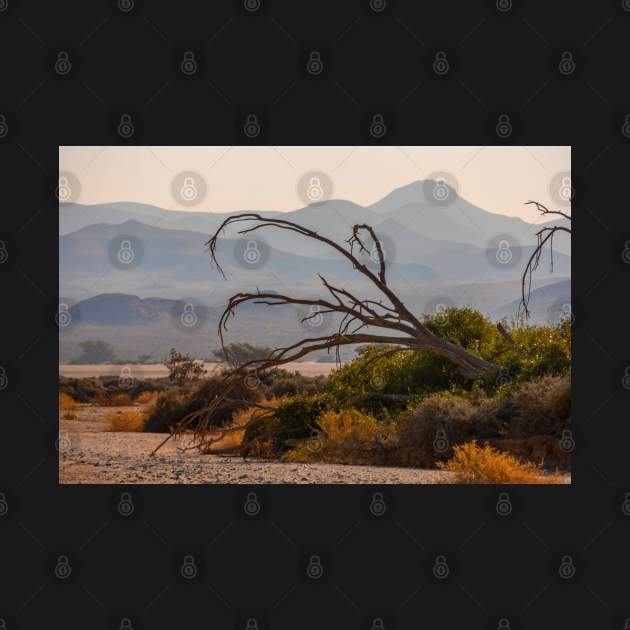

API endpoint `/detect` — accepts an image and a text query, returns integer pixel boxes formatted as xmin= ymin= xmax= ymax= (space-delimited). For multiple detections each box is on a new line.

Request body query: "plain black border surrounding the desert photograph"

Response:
xmin=0 ymin=0 xmax=630 ymax=630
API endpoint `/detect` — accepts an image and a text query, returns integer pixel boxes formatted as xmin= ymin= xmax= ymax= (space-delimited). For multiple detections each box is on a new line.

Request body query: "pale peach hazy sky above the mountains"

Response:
xmin=59 ymin=146 xmax=571 ymax=222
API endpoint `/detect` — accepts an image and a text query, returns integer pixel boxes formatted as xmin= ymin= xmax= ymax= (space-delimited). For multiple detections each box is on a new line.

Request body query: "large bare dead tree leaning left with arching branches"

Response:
xmin=154 ymin=213 xmax=498 ymax=453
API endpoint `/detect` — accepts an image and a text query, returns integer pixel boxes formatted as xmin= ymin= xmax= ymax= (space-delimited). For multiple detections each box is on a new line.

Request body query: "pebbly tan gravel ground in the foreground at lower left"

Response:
xmin=59 ymin=405 xmax=460 ymax=484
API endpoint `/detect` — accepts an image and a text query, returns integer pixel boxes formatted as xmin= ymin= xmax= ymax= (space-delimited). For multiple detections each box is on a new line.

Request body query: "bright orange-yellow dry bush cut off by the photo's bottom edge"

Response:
xmin=437 ymin=440 xmax=561 ymax=484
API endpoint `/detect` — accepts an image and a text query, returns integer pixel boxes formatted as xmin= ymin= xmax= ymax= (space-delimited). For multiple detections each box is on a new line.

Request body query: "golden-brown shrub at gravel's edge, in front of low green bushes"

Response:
xmin=283 ymin=409 xmax=388 ymax=465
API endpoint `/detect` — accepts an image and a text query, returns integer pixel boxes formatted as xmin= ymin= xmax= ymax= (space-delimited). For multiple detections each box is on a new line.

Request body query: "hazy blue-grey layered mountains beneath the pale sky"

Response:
xmin=59 ymin=181 xmax=571 ymax=360
